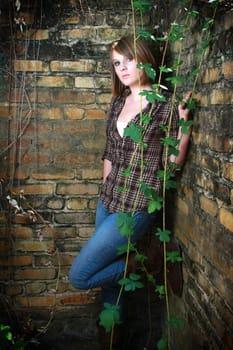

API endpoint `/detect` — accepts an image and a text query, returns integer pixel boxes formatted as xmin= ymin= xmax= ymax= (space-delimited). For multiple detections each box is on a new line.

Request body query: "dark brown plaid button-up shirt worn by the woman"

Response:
xmin=101 ymin=92 xmax=179 ymax=213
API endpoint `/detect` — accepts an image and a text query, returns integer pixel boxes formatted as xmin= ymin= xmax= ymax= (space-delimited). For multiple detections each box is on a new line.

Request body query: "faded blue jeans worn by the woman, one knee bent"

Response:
xmin=69 ymin=200 xmax=157 ymax=316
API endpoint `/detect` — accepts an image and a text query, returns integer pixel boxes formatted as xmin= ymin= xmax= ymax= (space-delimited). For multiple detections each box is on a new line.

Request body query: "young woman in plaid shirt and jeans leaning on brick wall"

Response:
xmin=70 ymin=37 xmax=192 ymax=348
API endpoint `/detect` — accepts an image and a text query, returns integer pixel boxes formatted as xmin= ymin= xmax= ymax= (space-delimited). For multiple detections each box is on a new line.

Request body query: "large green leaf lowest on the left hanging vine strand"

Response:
xmin=99 ymin=303 xmax=121 ymax=333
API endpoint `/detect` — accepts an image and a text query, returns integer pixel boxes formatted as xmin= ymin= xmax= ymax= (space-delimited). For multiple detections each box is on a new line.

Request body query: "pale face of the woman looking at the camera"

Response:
xmin=112 ymin=50 xmax=143 ymax=87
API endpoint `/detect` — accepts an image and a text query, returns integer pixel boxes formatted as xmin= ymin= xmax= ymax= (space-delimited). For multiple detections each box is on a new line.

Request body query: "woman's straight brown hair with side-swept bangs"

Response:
xmin=110 ymin=36 xmax=156 ymax=96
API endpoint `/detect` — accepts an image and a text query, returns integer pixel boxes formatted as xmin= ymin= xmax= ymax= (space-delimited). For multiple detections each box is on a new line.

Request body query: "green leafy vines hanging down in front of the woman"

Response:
xmin=100 ymin=0 xmax=218 ymax=350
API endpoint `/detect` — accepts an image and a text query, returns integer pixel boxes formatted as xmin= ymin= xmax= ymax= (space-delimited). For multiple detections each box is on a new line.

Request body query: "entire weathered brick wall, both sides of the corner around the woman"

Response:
xmin=0 ymin=0 xmax=233 ymax=350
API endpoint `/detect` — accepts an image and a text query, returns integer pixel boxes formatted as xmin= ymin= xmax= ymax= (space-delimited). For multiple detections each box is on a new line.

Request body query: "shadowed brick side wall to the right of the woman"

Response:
xmin=169 ymin=4 xmax=233 ymax=350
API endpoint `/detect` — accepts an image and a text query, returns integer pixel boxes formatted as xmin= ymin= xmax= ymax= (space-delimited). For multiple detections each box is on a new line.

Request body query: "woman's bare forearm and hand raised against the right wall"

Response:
xmin=170 ymin=92 xmax=192 ymax=167
